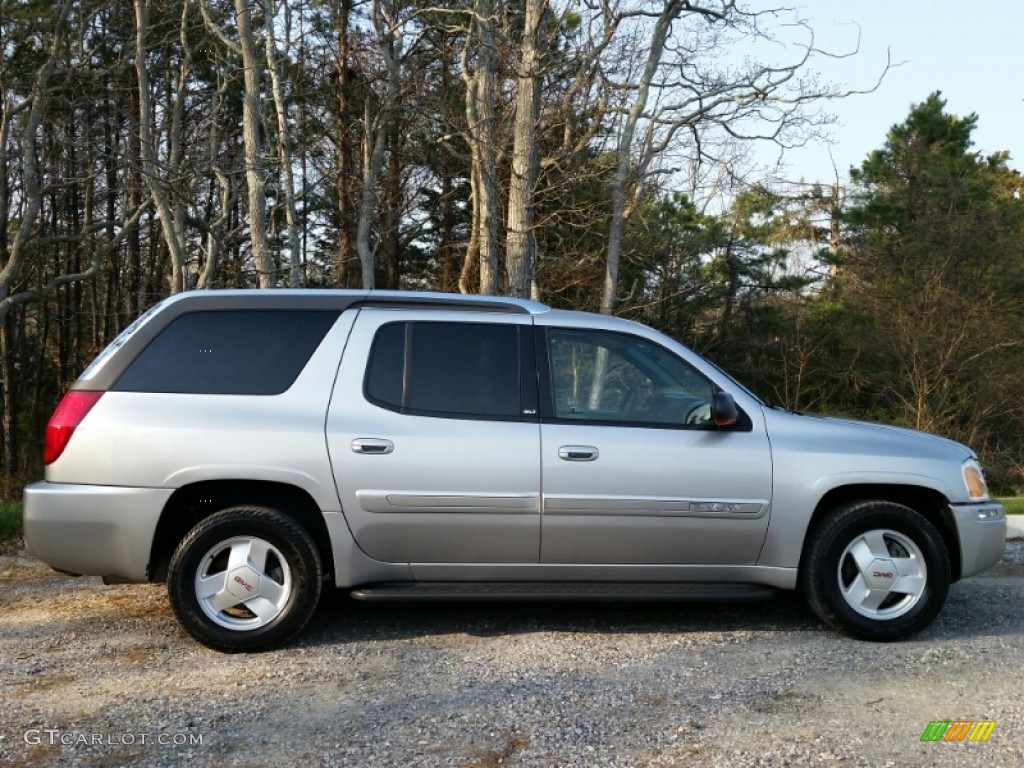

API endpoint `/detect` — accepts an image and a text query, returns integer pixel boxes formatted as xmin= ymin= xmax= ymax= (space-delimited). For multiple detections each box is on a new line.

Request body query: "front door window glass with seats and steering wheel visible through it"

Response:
xmin=548 ymin=328 xmax=715 ymax=427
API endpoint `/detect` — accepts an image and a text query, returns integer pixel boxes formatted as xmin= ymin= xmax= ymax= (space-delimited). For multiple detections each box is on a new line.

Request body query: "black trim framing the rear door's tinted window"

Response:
xmin=362 ymin=319 xmax=540 ymax=423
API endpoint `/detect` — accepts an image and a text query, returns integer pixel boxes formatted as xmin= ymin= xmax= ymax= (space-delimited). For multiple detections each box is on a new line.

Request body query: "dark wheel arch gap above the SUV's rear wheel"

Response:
xmin=147 ymin=480 xmax=334 ymax=582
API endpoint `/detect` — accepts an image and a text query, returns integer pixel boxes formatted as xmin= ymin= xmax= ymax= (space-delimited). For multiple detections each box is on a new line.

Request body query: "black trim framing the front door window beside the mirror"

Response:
xmin=535 ymin=326 xmax=754 ymax=432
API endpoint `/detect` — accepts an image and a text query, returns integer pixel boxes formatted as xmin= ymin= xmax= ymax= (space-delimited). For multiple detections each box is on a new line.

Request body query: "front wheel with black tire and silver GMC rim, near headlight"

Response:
xmin=800 ymin=501 xmax=950 ymax=641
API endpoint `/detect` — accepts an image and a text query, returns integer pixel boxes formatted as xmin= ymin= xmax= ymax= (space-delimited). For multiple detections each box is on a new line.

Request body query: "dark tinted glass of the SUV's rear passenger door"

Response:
xmin=366 ymin=323 xmax=520 ymax=418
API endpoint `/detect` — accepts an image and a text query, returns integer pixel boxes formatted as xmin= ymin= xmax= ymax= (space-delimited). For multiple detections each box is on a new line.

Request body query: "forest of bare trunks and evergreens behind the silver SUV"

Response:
xmin=0 ymin=0 xmax=1024 ymax=497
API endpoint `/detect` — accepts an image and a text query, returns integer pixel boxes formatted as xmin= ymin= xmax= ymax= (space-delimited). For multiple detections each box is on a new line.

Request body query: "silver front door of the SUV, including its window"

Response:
xmin=540 ymin=328 xmax=771 ymax=564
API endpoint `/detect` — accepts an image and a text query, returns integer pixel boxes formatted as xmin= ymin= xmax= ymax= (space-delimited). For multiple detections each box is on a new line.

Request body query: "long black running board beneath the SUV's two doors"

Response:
xmin=351 ymin=582 xmax=776 ymax=602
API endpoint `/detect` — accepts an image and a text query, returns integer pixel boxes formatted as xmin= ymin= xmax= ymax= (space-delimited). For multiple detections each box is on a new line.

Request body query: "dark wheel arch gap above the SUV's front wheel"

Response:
xmin=800 ymin=483 xmax=962 ymax=582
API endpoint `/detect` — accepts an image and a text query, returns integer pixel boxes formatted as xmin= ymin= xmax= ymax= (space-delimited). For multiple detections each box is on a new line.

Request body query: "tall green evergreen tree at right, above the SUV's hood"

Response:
xmin=837 ymin=93 xmax=1024 ymax=468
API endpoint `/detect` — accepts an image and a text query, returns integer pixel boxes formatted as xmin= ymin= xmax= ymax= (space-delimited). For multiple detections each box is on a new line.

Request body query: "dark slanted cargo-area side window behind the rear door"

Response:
xmin=113 ymin=309 xmax=338 ymax=394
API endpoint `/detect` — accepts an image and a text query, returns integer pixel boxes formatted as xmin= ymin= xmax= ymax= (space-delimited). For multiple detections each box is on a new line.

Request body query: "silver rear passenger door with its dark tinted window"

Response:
xmin=327 ymin=308 xmax=541 ymax=563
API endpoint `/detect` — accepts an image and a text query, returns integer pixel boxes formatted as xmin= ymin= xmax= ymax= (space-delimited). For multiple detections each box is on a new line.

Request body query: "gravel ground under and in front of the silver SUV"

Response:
xmin=0 ymin=542 xmax=1024 ymax=768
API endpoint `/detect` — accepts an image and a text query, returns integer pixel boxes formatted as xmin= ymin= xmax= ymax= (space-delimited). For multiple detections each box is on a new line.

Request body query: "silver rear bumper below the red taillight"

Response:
xmin=24 ymin=482 xmax=174 ymax=582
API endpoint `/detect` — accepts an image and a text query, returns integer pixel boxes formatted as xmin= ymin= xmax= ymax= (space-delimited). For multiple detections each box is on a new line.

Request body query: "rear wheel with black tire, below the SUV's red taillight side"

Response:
xmin=167 ymin=506 xmax=323 ymax=653
